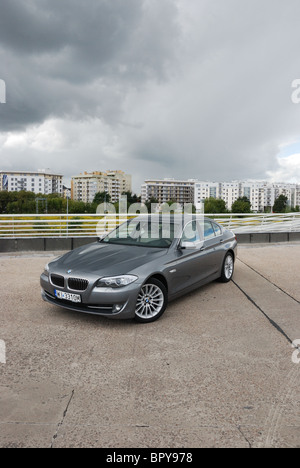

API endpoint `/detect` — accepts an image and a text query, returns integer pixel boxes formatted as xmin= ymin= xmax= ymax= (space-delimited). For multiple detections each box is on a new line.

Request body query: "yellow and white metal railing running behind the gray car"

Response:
xmin=0 ymin=213 xmax=300 ymax=239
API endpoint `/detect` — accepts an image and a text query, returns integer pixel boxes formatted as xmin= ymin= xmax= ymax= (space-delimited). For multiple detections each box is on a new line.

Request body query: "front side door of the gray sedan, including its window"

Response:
xmin=167 ymin=220 xmax=210 ymax=295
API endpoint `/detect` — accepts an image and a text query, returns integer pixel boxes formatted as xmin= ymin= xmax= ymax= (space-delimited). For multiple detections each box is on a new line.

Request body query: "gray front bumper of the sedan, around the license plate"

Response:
xmin=40 ymin=273 xmax=141 ymax=319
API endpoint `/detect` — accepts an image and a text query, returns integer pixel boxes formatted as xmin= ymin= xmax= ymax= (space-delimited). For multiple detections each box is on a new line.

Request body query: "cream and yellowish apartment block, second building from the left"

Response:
xmin=71 ymin=171 xmax=132 ymax=203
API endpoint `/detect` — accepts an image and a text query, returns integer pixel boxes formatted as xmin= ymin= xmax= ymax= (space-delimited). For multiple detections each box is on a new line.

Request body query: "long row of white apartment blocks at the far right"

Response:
xmin=194 ymin=180 xmax=300 ymax=212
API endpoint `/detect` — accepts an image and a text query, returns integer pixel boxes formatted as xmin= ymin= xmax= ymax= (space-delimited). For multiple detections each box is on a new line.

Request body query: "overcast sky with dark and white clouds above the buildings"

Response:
xmin=0 ymin=0 xmax=300 ymax=193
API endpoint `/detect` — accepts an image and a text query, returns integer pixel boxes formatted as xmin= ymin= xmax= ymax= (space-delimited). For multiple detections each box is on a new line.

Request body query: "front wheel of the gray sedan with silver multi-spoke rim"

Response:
xmin=135 ymin=278 xmax=168 ymax=323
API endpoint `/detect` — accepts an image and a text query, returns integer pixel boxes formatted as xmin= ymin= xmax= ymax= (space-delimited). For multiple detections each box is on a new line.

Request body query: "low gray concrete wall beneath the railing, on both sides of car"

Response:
xmin=0 ymin=232 xmax=300 ymax=252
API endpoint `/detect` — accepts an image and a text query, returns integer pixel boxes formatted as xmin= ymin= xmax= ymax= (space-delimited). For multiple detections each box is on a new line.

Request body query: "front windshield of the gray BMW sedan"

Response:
xmin=102 ymin=219 xmax=180 ymax=248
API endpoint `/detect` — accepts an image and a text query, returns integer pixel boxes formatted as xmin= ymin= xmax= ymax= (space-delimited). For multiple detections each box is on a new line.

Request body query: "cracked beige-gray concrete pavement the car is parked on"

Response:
xmin=0 ymin=244 xmax=300 ymax=448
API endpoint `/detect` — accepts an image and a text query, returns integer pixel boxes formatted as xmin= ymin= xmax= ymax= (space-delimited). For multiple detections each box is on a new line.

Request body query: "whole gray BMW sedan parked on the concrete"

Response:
xmin=40 ymin=215 xmax=237 ymax=323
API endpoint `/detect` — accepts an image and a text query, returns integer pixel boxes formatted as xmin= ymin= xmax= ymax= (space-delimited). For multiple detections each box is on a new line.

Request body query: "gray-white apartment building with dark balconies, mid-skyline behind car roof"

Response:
xmin=141 ymin=178 xmax=195 ymax=206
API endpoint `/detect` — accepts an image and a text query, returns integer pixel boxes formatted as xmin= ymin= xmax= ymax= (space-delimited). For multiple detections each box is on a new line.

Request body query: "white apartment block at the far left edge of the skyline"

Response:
xmin=0 ymin=169 xmax=63 ymax=195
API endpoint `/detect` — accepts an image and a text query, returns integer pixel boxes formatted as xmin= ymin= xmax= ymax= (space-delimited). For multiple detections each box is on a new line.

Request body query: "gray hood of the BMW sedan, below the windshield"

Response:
xmin=50 ymin=242 xmax=168 ymax=276
